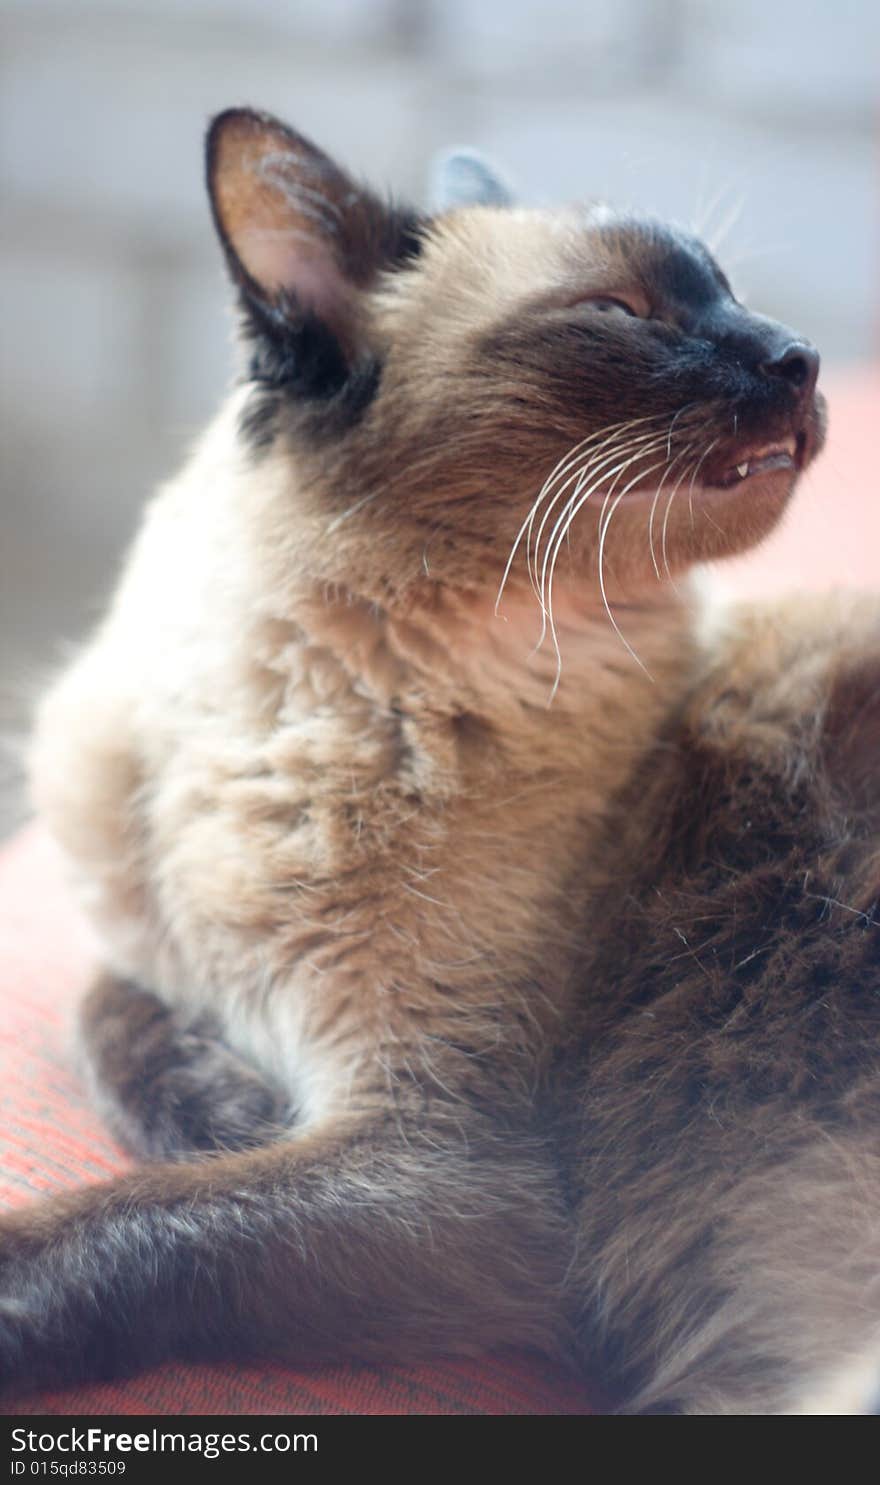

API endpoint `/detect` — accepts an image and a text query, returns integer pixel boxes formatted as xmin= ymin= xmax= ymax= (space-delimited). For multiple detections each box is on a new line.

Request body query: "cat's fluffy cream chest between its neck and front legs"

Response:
xmin=66 ymin=582 xmax=673 ymax=1109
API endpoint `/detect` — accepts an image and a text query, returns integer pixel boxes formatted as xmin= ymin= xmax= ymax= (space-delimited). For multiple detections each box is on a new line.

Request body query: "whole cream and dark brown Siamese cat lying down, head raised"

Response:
xmin=0 ymin=110 xmax=880 ymax=1412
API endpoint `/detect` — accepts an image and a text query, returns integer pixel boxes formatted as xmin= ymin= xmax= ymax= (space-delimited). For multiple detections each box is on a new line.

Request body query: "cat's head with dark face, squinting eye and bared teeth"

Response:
xmin=208 ymin=110 xmax=824 ymax=598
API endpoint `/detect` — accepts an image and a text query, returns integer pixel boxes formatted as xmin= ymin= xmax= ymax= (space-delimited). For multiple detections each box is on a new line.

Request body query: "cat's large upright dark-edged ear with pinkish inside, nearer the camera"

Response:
xmin=206 ymin=108 xmax=417 ymax=361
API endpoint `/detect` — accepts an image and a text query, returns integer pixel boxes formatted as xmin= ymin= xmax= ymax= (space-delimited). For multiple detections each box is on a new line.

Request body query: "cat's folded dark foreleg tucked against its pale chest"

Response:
xmin=80 ymin=973 xmax=292 ymax=1160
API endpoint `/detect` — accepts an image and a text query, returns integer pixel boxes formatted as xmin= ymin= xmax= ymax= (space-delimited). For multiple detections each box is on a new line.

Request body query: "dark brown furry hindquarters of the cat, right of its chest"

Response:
xmin=555 ymin=605 xmax=880 ymax=1412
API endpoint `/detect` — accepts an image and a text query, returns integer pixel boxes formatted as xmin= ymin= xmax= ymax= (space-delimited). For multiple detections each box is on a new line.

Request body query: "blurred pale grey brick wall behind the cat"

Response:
xmin=0 ymin=0 xmax=880 ymax=832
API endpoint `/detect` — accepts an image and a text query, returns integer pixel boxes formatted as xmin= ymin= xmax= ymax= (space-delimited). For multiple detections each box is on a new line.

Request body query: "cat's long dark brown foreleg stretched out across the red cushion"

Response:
xmin=0 ymin=1108 xmax=567 ymax=1390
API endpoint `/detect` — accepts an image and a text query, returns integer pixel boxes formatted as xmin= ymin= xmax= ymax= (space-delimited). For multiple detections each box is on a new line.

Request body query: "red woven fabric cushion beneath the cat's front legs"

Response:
xmin=0 ymin=829 xmax=597 ymax=1415
